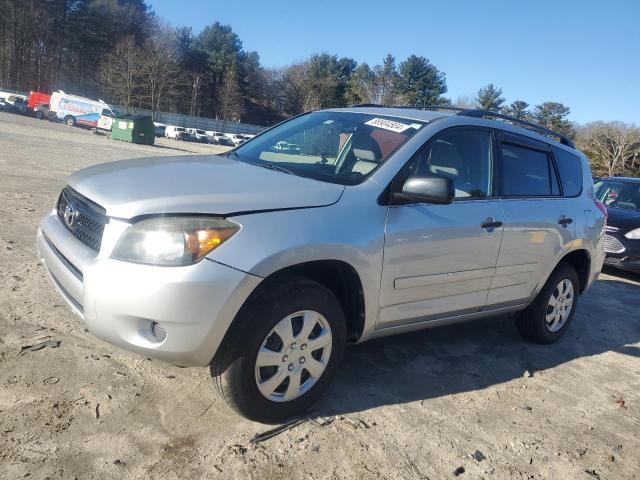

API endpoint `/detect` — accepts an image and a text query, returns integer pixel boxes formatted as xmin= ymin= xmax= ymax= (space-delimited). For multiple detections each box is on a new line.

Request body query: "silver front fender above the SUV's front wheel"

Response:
xmin=209 ymin=183 xmax=387 ymax=335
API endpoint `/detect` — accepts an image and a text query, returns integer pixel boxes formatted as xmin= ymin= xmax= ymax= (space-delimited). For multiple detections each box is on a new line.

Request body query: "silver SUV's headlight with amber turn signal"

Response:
xmin=111 ymin=217 xmax=240 ymax=266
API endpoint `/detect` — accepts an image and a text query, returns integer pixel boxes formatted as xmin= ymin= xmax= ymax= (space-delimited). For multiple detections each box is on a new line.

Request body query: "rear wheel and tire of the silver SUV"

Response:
xmin=516 ymin=263 xmax=580 ymax=344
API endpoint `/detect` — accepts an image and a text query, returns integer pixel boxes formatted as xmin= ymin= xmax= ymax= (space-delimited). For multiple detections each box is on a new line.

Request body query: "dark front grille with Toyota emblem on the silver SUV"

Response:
xmin=56 ymin=187 xmax=108 ymax=252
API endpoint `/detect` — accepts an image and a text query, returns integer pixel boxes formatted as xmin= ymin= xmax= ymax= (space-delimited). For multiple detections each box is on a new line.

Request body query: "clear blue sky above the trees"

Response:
xmin=148 ymin=0 xmax=640 ymax=125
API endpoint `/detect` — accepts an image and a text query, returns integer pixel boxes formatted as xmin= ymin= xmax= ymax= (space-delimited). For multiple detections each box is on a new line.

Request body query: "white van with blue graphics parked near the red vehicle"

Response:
xmin=49 ymin=90 xmax=115 ymax=130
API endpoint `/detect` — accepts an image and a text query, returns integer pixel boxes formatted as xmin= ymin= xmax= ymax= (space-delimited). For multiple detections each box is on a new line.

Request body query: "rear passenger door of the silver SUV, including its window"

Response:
xmin=487 ymin=131 xmax=577 ymax=306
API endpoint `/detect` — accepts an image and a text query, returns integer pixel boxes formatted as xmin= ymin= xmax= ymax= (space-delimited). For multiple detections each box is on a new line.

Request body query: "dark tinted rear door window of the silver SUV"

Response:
xmin=501 ymin=143 xmax=560 ymax=197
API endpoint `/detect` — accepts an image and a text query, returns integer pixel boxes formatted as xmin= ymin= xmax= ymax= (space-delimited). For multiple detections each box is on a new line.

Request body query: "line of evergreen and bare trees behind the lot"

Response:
xmin=0 ymin=0 xmax=640 ymax=175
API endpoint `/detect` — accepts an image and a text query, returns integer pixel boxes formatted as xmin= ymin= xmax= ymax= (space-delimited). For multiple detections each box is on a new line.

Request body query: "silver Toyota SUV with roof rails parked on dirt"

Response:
xmin=37 ymin=106 xmax=606 ymax=422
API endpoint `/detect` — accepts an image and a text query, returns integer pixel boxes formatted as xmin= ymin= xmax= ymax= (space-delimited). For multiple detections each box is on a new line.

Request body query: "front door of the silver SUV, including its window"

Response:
xmin=377 ymin=127 xmax=504 ymax=328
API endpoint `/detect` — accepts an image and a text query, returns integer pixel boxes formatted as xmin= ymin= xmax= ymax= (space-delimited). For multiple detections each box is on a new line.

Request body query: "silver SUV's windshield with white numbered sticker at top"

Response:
xmin=229 ymin=111 xmax=424 ymax=185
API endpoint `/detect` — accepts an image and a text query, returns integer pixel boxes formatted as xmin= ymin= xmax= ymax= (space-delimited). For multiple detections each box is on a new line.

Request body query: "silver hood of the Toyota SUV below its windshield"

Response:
xmin=67 ymin=155 xmax=345 ymax=219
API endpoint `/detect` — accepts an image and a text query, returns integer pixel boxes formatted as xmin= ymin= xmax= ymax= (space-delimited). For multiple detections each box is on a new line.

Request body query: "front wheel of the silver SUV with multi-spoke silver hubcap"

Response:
xmin=211 ymin=277 xmax=346 ymax=423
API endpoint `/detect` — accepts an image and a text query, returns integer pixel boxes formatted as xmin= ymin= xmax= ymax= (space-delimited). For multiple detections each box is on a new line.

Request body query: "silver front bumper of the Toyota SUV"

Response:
xmin=37 ymin=211 xmax=262 ymax=366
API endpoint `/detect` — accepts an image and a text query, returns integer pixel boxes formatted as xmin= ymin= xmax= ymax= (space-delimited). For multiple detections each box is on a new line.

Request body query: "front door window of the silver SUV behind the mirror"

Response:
xmin=409 ymin=128 xmax=493 ymax=198
